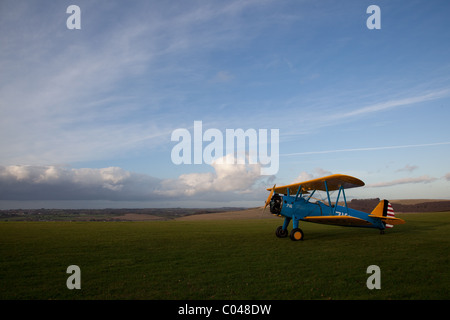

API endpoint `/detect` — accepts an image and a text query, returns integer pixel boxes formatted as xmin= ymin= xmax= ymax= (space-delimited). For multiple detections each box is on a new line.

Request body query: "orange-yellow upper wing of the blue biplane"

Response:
xmin=267 ymin=174 xmax=364 ymax=194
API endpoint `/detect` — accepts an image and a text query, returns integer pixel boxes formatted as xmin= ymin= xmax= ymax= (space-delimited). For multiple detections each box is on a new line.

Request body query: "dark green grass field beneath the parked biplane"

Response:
xmin=0 ymin=212 xmax=450 ymax=300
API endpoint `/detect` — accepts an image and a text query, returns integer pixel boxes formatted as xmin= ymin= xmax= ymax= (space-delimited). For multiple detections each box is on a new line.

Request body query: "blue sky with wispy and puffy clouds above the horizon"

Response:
xmin=0 ymin=0 xmax=450 ymax=209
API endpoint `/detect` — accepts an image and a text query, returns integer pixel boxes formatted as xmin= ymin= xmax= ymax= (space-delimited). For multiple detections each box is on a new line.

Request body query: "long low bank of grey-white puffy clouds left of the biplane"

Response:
xmin=0 ymin=155 xmax=267 ymax=205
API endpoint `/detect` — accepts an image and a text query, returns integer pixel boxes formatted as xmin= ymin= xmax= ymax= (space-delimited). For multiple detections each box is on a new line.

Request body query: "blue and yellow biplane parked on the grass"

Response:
xmin=264 ymin=174 xmax=405 ymax=241
